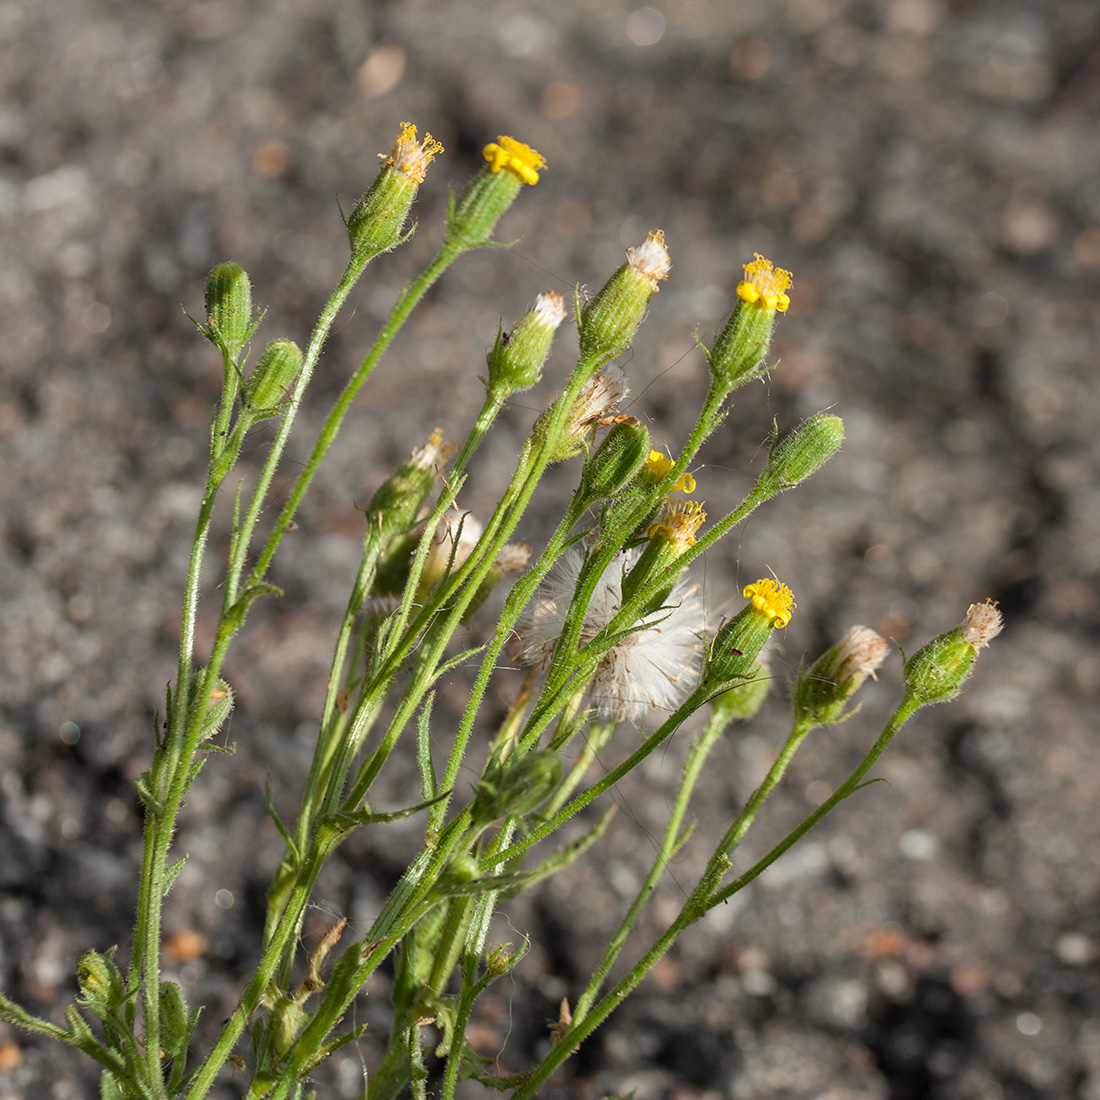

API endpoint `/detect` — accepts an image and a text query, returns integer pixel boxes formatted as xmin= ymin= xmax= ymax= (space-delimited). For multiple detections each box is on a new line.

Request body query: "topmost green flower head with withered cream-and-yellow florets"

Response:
xmin=345 ymin=122 xmax=443 ymax=260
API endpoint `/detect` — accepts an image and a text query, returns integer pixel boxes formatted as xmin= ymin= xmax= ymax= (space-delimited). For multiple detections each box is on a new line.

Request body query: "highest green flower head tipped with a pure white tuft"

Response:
xmin=576 ymin=229 xmax=672 ymax=362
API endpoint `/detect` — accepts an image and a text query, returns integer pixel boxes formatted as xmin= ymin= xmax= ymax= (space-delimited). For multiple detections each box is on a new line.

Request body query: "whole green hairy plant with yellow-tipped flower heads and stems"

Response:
xmin=0 ymin=124 xmax=1001 ymax=1100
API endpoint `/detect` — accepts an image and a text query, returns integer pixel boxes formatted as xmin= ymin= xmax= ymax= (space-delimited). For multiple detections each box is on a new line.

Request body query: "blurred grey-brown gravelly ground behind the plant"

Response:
xmin=0 ymin=0 xmax=1100 ymax=1100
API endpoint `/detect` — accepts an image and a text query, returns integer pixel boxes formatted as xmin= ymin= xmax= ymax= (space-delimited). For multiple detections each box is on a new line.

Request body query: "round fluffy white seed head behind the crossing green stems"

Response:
xmin=516 ymin=548 xmax=704 ymax=721
